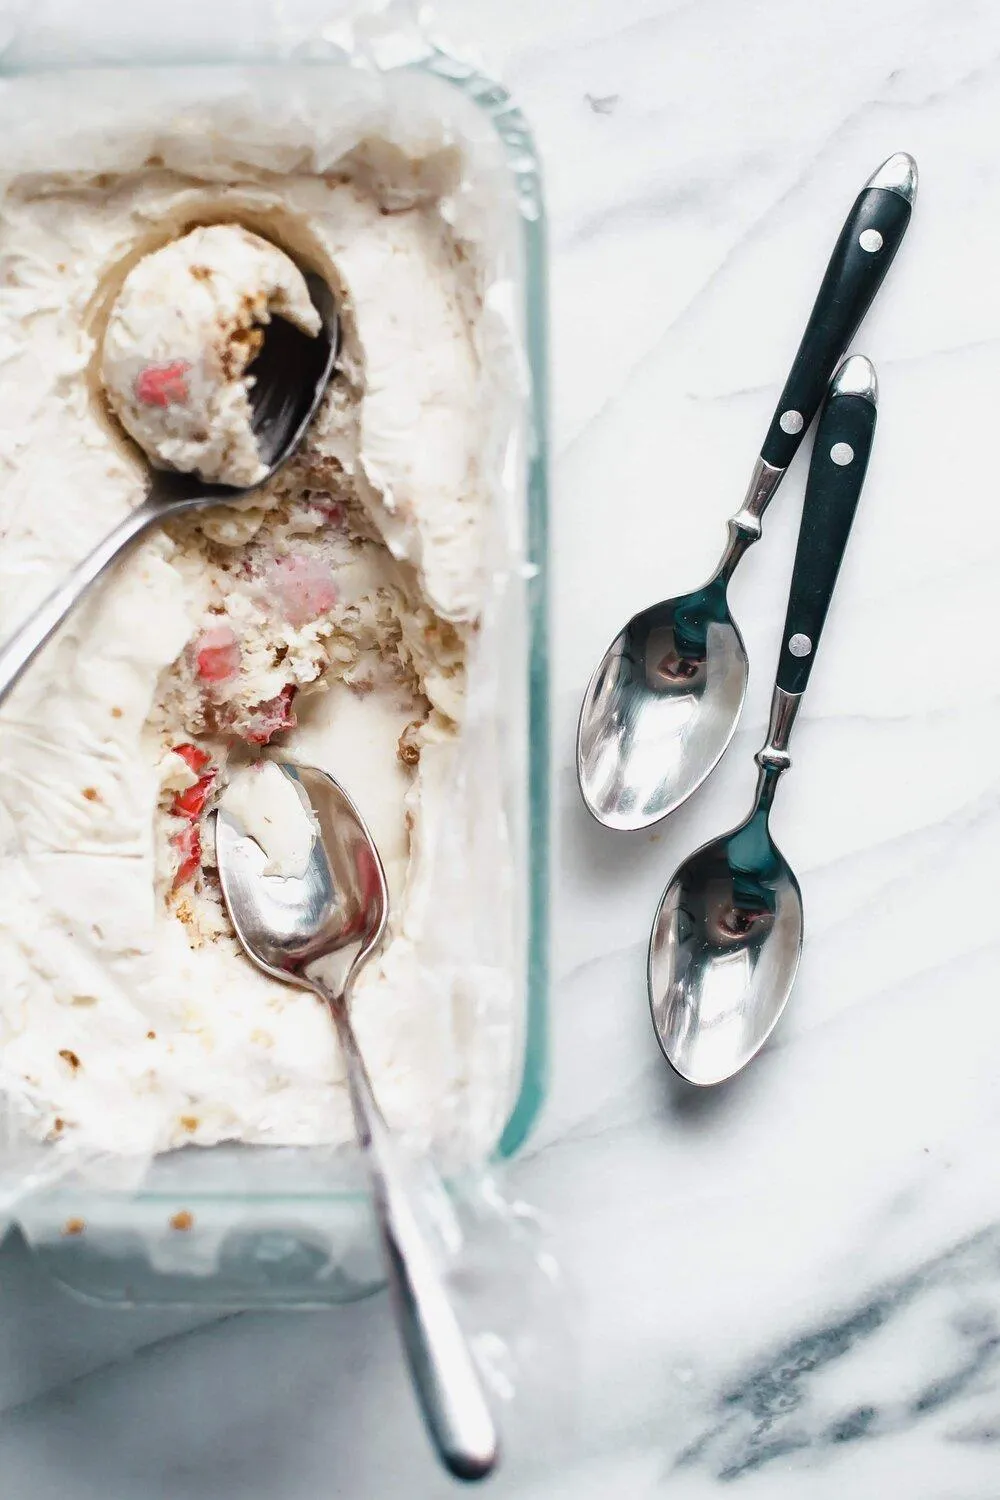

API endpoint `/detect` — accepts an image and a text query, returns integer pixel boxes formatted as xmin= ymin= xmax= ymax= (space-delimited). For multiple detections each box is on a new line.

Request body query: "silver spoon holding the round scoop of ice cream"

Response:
xmin=0 ymin=275 xmax=340 ymax=704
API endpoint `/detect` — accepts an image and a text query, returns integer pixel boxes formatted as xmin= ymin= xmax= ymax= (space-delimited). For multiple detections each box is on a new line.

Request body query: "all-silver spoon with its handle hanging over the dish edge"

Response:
xmin=216 ymin=761 xmax=498 ymax=1479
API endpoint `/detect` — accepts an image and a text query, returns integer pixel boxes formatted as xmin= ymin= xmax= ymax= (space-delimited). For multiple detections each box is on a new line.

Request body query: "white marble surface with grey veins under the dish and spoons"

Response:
xmin=0 ymin=0 xmax=1000 ymax=1500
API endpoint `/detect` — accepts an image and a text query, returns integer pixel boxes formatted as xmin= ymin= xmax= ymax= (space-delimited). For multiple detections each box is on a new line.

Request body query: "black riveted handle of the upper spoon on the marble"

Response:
xmin=760 ymin=152 xmax=916 ymax=470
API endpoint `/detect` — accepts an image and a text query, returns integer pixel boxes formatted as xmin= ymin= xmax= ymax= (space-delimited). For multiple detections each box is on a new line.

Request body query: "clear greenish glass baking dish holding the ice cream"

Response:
xmin=0 ymin=47 xmax=549 ymax=1308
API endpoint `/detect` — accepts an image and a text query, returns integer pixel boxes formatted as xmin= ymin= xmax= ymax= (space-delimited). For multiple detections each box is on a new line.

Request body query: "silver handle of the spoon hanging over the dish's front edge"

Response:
xmin=324 ymin=990 xmax=498 ymax=1479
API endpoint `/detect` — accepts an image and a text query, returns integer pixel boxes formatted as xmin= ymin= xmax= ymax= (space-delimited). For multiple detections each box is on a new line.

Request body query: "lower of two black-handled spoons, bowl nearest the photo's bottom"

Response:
xmin=649 ymin=354 xmax=877 ymax=1085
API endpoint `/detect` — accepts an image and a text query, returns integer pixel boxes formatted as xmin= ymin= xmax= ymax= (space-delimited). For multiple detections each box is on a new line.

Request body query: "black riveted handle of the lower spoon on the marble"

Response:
xmin=775 ymin=354 xmax=879 ymax=695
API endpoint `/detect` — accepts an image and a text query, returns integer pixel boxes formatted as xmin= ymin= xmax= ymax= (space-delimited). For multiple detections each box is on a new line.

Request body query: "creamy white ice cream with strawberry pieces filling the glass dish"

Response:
xmin=0 ymin=96 xmax=513 ymax=1154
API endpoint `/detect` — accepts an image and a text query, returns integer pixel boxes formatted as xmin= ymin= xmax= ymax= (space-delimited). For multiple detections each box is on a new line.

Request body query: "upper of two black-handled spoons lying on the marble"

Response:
xmin=577 ymin=152 xmax=916 ymax=830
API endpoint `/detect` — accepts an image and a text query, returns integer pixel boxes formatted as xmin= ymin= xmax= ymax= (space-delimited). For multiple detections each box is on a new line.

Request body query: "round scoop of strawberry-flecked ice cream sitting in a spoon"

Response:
xmin=100 ymin=224 xmax=319 ymax=488
